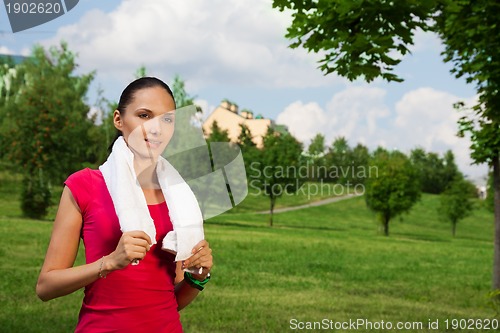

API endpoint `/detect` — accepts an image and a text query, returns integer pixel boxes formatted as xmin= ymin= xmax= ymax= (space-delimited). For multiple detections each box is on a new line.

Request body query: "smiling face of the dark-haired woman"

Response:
xmin=113 ymin=87 xmax=175 ymax=161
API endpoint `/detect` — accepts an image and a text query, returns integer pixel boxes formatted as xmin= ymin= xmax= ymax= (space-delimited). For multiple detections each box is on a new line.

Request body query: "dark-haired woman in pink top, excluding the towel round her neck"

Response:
xmin=36 ymin=77 xmax=213 ymax=333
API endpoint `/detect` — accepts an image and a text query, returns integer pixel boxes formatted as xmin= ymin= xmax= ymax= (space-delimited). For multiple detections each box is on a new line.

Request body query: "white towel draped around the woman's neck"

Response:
xmin=99 ymin=136 xmax=204 ymax=261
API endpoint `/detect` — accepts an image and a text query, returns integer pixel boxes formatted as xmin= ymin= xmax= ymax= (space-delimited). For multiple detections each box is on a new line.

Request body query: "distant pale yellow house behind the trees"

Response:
xmin=202 ymin=100 xmax=286 ymax=148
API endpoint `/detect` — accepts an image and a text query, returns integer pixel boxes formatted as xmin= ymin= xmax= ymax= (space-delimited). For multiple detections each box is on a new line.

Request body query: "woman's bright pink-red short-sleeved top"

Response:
xmin=65 ymin=169 xmax=182 ymax=333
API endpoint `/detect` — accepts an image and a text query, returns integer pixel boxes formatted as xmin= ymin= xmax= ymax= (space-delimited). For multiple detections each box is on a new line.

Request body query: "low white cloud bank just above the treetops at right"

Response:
xmin=276 ymin=86 xmax=486 ymax=178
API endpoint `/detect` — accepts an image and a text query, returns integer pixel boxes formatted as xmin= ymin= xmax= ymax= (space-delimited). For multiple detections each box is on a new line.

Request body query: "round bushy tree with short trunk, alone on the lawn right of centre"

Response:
xmin=365 ymin=150 xmax=420 ymax=236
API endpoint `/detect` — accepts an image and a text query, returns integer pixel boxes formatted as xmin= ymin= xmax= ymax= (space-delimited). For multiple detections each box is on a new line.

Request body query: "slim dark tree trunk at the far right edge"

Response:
xmin=492 ymin=153 xmax=500 ymax=290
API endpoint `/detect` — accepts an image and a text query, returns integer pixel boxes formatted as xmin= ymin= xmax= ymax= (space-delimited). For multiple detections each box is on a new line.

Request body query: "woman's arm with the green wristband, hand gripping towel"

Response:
xmin=175 ymin=240 xmax=213 ymax=310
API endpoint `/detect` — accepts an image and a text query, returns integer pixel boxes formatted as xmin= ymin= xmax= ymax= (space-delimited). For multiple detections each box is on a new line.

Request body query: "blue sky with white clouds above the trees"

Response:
xmin=0 ymin=0 xmax=488 ymax=183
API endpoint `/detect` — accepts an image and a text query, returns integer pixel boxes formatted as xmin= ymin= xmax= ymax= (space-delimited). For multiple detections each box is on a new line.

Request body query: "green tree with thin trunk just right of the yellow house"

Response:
xmin=249 ymin=127 xmax=302 ymax=227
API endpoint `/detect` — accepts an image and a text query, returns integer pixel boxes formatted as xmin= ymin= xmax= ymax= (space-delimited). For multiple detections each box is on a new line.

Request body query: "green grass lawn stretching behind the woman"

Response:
xmin=0 ymin=175 xmax=497 ymax=333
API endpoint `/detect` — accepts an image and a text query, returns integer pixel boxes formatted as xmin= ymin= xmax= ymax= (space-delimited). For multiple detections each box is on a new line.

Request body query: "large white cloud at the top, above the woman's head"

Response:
xmin=46 ymin=0 xmax=340 ymax=87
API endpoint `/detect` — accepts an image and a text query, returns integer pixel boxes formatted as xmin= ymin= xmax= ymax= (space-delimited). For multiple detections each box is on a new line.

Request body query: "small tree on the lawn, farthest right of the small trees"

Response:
xmin=438 ymin=177 xmax=475 ymax=237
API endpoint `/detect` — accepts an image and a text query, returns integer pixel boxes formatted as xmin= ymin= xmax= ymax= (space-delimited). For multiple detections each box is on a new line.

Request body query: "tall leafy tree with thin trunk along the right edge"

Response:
xmin=442 ymin=0 xmax=500 ymax=289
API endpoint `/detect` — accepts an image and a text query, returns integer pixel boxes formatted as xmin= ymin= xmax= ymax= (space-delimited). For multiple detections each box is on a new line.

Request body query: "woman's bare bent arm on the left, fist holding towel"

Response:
xmin=36 ymin=187 xmax=151 ymax=301
